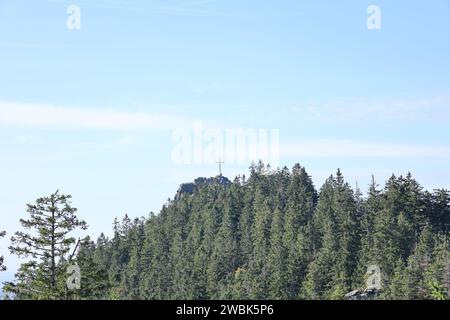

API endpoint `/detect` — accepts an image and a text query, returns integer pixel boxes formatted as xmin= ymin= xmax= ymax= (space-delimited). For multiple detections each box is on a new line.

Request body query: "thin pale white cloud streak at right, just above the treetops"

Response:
xmin=280 ymin=140 xmax=450 ymax=158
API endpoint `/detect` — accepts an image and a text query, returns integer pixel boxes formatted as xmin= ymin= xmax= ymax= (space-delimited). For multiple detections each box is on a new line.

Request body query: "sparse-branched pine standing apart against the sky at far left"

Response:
xmin=5 ymin=191 xmax=87 ymax=299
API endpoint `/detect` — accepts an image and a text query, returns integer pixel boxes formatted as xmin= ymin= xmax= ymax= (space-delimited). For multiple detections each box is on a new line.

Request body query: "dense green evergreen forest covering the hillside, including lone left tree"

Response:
xmin=0 ymin=163 xmax=450 ymax=300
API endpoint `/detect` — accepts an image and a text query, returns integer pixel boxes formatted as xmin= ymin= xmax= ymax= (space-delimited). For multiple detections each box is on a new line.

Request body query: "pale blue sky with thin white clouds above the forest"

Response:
xmin=0 ymin=0 xmax=450 ymax=276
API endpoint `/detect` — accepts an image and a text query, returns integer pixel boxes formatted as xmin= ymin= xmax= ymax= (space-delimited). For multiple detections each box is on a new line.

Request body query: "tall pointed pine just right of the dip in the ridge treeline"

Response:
xmin=305 ymin=170 xmax=360 ymax=299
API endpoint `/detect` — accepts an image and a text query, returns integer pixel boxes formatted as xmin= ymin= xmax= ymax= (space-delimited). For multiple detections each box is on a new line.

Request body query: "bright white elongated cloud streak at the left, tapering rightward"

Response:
xmin=0 ymin=102 xmax=192 ymax=131
